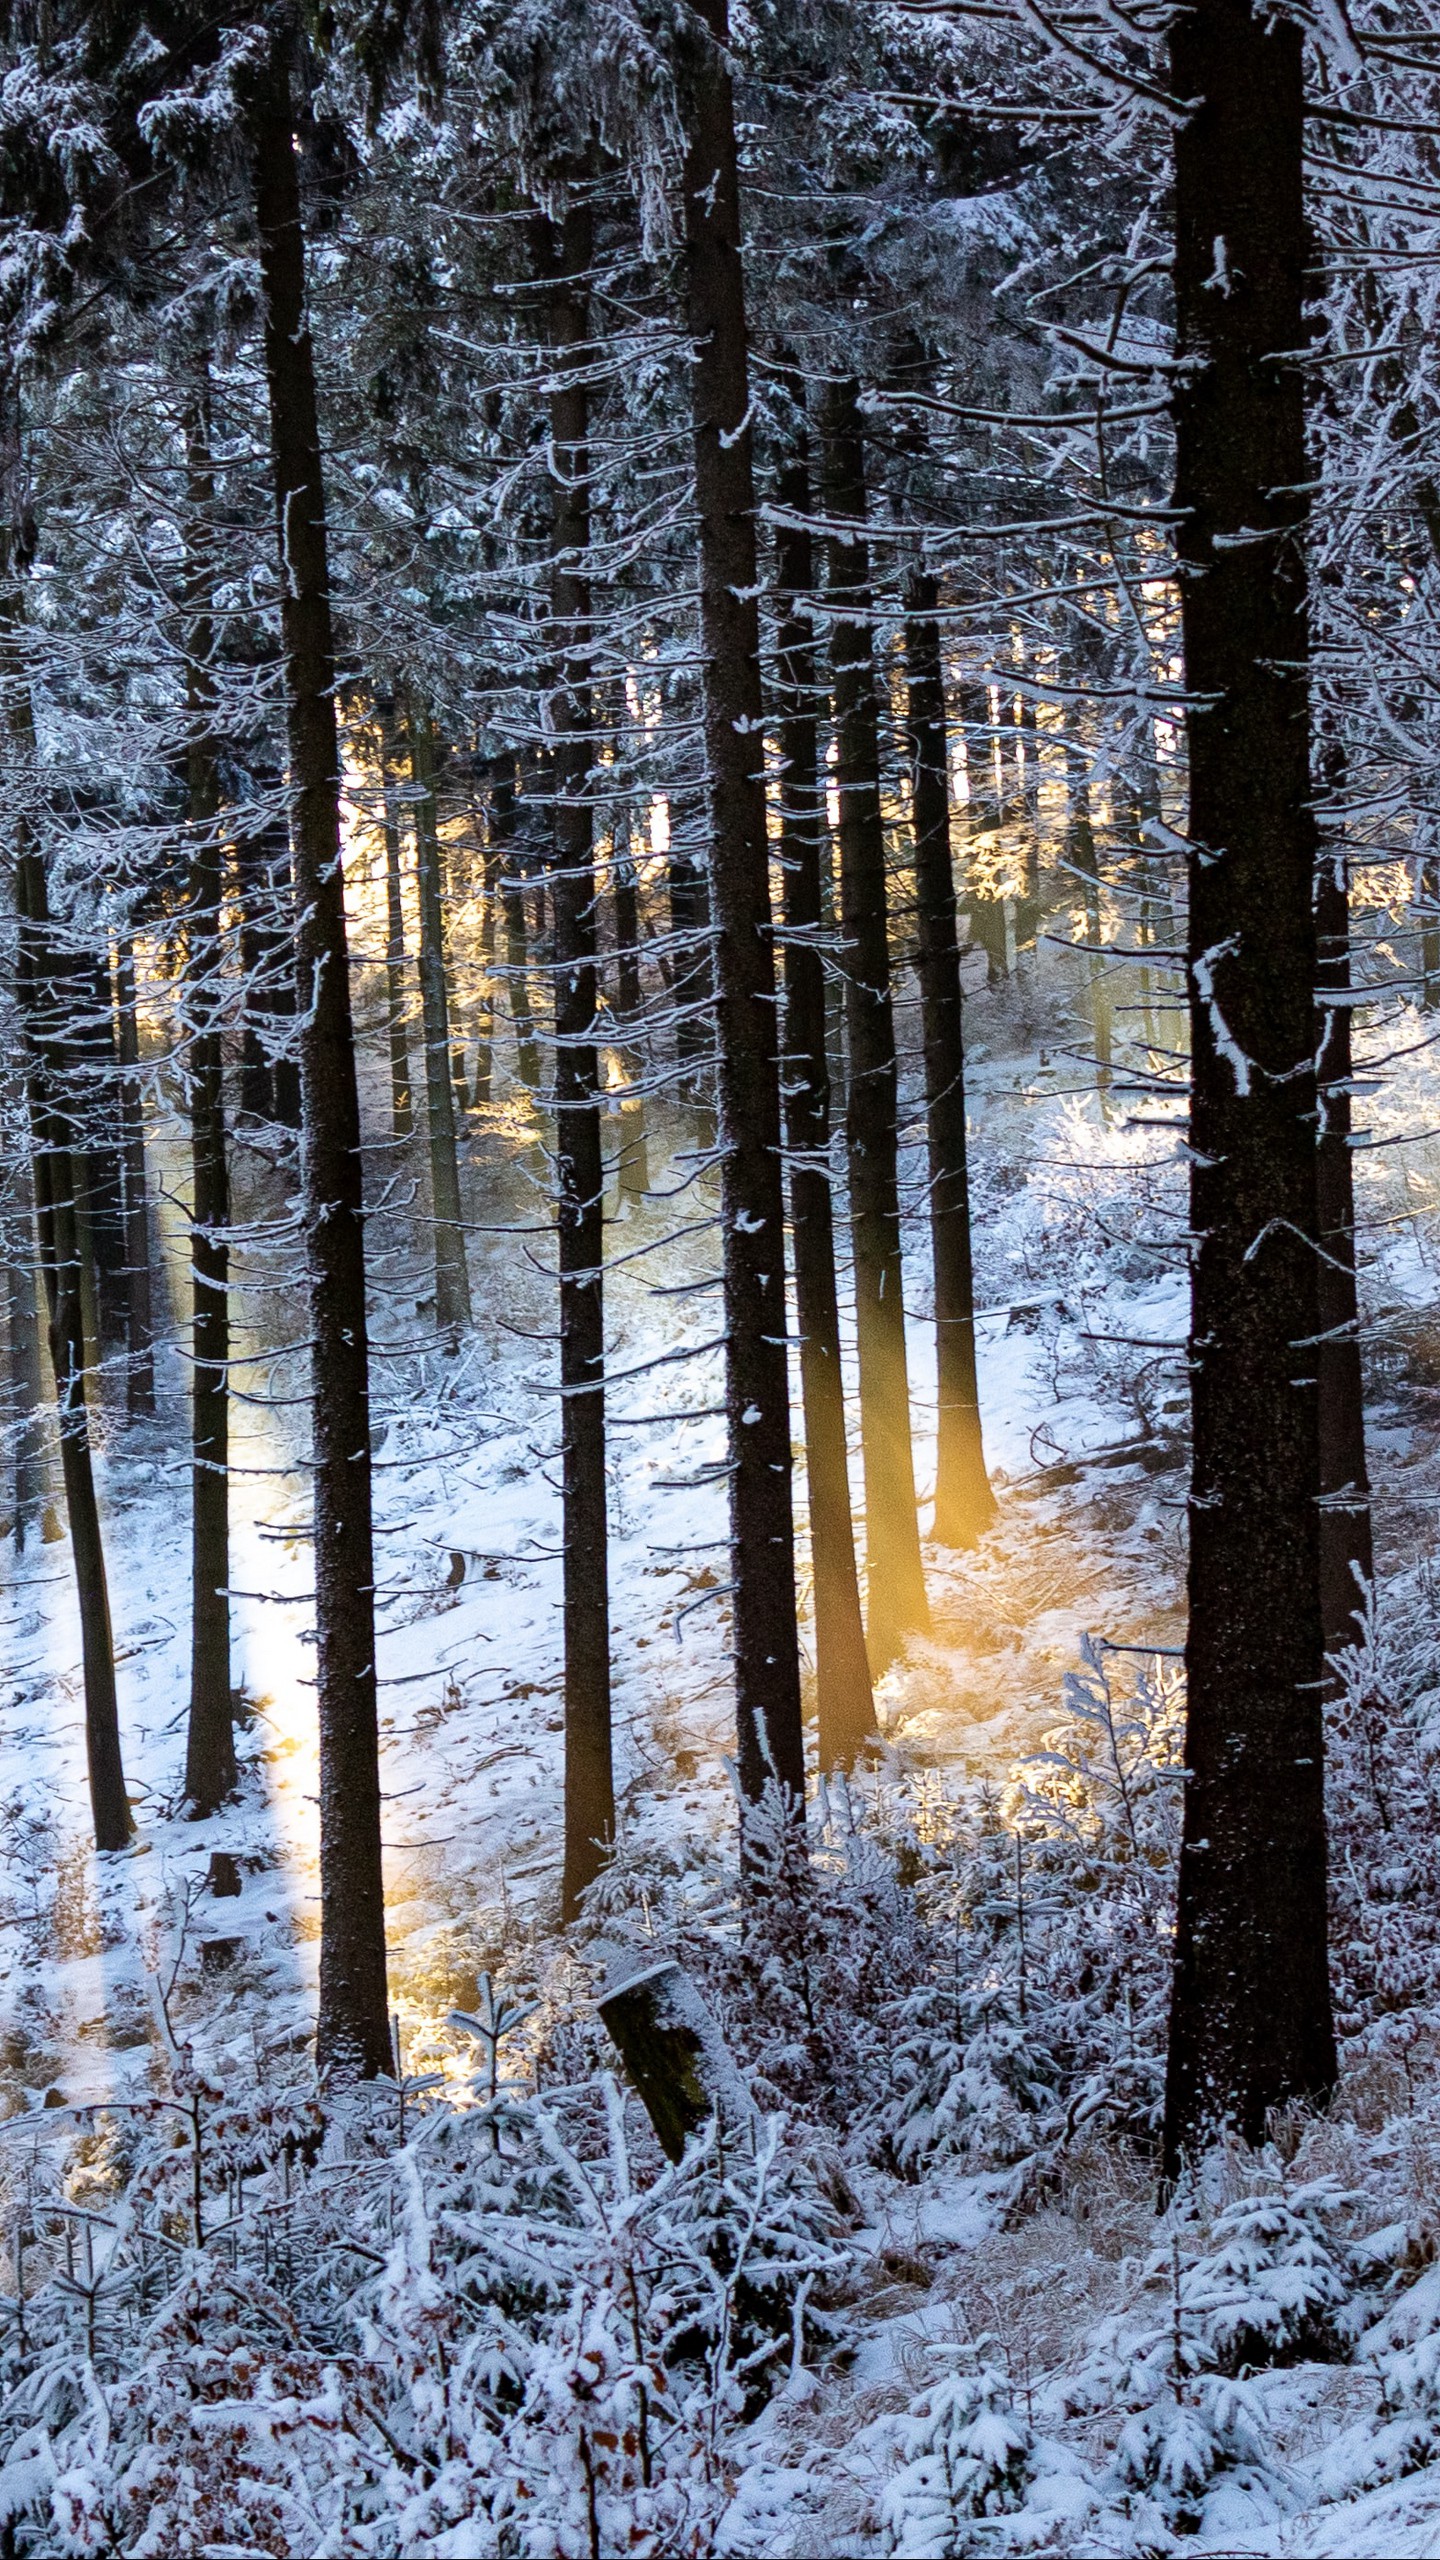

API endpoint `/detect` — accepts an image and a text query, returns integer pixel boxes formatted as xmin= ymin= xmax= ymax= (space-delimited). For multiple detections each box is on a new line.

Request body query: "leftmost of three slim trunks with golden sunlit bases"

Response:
xmin=776 ymin=453 xmax=879 ymax=1769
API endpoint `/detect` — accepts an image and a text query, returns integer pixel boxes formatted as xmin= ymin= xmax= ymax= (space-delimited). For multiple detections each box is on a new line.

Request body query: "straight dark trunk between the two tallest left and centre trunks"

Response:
xmin=536 ymin=205 xmax=615 ymax=1920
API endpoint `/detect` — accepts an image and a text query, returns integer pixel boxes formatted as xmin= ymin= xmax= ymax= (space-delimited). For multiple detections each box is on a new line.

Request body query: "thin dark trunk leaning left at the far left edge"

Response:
xmin=10 ymin=793 xmax=136 ymax=1848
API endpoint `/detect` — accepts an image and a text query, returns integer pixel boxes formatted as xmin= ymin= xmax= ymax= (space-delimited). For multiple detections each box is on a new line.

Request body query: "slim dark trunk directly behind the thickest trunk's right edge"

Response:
xmin=1314 ymin=850 xmax=1376 ymax=1654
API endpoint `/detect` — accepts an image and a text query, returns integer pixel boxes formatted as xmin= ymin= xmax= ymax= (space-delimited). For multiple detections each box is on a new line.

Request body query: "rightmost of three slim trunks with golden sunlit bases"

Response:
xmin=904 ymin=573 xmax=994 ymax=1546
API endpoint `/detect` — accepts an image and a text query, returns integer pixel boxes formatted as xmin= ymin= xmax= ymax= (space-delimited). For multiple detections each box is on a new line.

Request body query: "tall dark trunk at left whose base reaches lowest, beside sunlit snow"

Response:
xmin=254 ymin=49 xmax=392 ymax=2079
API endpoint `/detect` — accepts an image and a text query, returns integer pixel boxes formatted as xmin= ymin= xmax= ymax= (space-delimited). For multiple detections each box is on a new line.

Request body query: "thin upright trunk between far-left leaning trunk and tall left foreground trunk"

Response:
xmin=184 ymin=384 xmax=236 ymax=1815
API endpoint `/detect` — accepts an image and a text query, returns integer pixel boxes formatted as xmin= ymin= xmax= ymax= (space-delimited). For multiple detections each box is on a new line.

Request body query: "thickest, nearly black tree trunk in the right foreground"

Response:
xmin=1163 ymin=0 xmax=1335 ymax=2176
